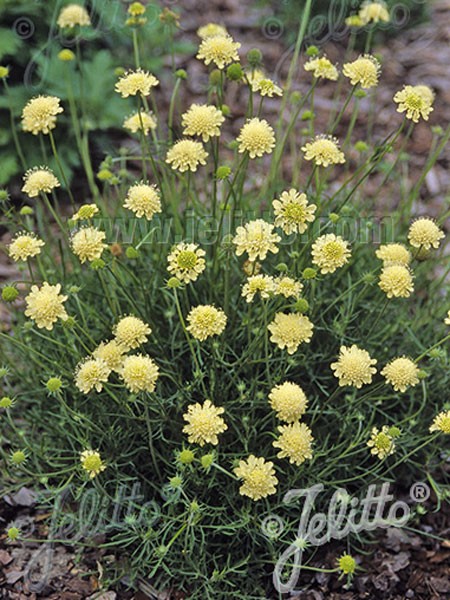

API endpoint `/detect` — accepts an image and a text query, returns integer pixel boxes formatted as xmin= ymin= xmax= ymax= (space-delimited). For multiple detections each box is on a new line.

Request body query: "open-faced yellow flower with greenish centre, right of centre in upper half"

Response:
xmin=272 ymin=188 xmax=317 ymax=235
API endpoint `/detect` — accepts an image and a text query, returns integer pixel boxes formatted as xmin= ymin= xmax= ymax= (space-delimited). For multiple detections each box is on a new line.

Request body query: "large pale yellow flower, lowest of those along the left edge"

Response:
xmin=25 ymin=281 xmax=68 ymax=331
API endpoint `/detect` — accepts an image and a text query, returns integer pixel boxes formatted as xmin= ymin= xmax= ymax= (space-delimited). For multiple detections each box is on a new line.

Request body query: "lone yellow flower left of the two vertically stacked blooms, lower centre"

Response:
xmin=183 ymin=400 xmax=228 ymax=446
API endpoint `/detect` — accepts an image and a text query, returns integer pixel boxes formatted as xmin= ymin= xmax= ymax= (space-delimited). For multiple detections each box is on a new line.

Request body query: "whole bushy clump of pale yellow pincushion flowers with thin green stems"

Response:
xmin=0 ymin=0 xmax=450 ymax=600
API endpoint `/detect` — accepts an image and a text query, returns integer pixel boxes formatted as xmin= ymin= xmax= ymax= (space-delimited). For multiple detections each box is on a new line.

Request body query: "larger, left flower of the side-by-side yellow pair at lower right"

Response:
xmin=331 ymin=344 xmax=377 ymax=389
